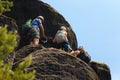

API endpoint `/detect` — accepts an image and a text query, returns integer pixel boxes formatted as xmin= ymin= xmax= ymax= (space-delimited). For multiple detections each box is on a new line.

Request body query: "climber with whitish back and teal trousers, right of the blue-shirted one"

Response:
xmin=53 ymin=26 xmax=72 ymax=52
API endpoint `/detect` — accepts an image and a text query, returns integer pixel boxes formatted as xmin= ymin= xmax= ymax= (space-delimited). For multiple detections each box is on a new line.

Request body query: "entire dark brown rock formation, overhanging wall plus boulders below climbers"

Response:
xmin=0 ymin=0 xmax=111 ymax=80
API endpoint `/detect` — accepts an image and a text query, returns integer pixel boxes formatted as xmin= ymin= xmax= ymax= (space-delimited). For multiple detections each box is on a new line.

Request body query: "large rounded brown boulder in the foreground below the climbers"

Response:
xmin=13 ymin=46 xmax=99 ymax=80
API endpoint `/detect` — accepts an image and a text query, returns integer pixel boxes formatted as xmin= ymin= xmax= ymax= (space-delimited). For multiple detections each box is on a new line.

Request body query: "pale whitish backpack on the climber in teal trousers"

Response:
xmin=55 ymin=31 xmax=68 ymax=43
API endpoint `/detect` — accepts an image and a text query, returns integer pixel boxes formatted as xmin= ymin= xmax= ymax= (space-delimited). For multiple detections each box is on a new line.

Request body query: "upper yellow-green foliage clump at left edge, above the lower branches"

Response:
xmin=0 ymin=27 xmax=16 ymax=59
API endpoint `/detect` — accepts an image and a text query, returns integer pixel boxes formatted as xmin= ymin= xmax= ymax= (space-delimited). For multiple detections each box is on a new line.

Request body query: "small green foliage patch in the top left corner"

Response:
xmin=0 ymin=0 xmax=13 ymax=14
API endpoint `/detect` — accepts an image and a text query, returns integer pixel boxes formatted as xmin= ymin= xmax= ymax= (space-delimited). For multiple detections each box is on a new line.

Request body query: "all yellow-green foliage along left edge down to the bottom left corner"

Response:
xmin=0 ymin=26 xmax=35 ymax=80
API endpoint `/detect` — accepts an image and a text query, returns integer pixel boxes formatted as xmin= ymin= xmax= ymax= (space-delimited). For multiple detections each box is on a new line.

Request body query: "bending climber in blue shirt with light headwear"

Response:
xmin=30 ymin=16 xmax=47 ymax=45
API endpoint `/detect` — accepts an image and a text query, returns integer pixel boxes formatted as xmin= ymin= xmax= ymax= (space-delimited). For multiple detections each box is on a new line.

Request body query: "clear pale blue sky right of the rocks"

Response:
xmin=43 ymin=0 xmax=120 ymax=80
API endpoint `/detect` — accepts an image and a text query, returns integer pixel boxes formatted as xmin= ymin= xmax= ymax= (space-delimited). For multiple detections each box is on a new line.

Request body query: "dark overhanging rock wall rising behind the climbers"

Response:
xmin=4 ymin=0 xmax=77 ymax=49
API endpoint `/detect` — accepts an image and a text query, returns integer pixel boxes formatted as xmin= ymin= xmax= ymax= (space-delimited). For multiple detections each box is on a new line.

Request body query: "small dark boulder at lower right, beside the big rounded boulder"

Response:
xmin=90 ymin=61 xmax=111 ymax=80
